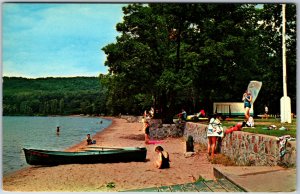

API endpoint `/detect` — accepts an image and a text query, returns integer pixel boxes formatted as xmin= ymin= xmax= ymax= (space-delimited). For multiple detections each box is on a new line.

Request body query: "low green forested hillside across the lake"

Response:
xmin=3 ymin=77 xmax=107 ymax=115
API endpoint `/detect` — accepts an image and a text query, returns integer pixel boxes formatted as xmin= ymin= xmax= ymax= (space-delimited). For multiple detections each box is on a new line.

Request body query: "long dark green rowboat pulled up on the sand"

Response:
xmin=23 ymin=147 xmax=147 ymax=165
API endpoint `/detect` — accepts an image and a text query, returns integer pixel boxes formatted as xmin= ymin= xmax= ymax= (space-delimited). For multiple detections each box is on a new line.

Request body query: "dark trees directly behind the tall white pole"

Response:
xmin=257 ymin=4 xmax=297 ymax=113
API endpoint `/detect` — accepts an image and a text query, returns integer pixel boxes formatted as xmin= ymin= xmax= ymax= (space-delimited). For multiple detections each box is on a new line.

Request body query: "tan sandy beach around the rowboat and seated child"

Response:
xmin=3 ymin=118 xmax=216 ymax=192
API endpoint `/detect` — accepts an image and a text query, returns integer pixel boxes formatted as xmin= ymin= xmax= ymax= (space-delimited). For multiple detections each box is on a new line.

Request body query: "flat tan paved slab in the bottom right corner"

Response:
xmin=214 ymin=166 xmax=297 ymax=192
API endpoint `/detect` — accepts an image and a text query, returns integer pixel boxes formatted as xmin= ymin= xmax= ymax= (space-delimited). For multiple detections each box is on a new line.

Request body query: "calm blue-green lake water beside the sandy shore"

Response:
xmin=2 ymin=116 xmax=111 ymax=175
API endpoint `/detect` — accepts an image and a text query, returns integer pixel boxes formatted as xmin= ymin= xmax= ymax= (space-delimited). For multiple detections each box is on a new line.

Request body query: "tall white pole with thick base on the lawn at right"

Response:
xmin=280 ymin=4 xmax=292 ymax=123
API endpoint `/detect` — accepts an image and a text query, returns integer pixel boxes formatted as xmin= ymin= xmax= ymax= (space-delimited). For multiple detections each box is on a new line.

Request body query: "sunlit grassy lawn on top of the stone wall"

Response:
xmin=222 ymin=118 xmax=297 ymax=138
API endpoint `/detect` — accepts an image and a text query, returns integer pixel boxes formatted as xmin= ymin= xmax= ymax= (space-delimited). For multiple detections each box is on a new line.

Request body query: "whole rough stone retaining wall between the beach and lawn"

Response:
xmin=121 ymin=116 xmax=297 ymax=167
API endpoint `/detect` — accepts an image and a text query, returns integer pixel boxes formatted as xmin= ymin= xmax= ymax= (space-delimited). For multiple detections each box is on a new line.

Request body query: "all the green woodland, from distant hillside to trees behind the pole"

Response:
xmin=3 ymin=3 xmax=297 ymax=123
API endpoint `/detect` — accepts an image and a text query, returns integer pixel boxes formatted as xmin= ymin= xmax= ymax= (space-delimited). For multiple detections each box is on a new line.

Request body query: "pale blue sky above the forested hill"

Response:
xmin=2 ymin=3 xmax=125 ymax=78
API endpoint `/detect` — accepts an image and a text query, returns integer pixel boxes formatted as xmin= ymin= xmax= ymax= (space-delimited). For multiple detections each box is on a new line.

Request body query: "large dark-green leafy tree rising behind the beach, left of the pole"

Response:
xmin=103 ymin=3 xmax=295 ymax=122
